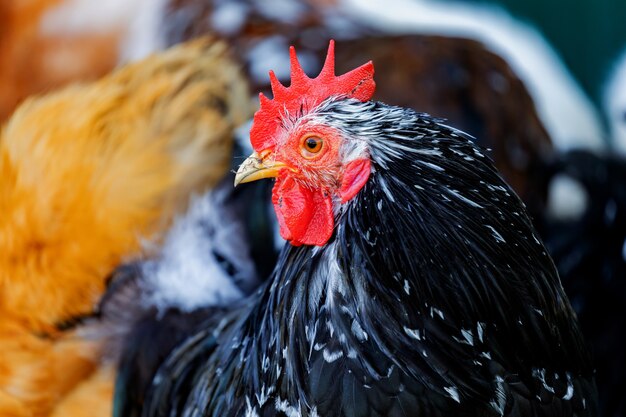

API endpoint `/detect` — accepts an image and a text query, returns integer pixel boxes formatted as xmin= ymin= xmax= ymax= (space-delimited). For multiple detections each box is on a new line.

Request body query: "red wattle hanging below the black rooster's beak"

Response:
xmin=272 ymin=176 xmax=335 ymax=246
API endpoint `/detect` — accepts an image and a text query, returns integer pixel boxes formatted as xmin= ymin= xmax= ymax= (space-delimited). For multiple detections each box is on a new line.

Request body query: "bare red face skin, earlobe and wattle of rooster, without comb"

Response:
xmin=266 ymin=126 xmax=371 ymax=246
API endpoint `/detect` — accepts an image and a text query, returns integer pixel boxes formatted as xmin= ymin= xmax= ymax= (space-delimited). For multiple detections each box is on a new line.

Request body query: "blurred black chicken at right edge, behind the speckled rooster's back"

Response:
xmin=535 ymin=151 xmax=626 ymax=417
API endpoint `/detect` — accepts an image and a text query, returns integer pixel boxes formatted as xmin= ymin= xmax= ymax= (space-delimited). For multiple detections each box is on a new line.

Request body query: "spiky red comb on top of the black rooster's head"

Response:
xmin=250 ymin=40 xmax=376 ymax=152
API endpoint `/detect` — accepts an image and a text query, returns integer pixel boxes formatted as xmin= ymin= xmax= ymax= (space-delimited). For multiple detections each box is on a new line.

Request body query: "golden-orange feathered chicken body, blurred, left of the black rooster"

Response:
xmin=0 ymin=39 xmax=250 ymax=417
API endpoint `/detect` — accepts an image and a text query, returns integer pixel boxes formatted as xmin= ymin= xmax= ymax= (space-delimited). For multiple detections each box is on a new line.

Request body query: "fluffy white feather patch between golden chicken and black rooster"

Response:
xmin=143 ymin=188 xmax=255 ymax=311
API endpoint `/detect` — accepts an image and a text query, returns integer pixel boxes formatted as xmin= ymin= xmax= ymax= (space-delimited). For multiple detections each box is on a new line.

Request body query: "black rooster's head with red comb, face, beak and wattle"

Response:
xmin=235 ymin=41 xmax=375 ymax=246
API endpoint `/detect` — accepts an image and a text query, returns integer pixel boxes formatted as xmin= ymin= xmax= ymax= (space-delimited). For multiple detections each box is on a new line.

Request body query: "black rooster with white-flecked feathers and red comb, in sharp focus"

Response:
xmin=122 ymin=42 xmax=597 ymax=417
